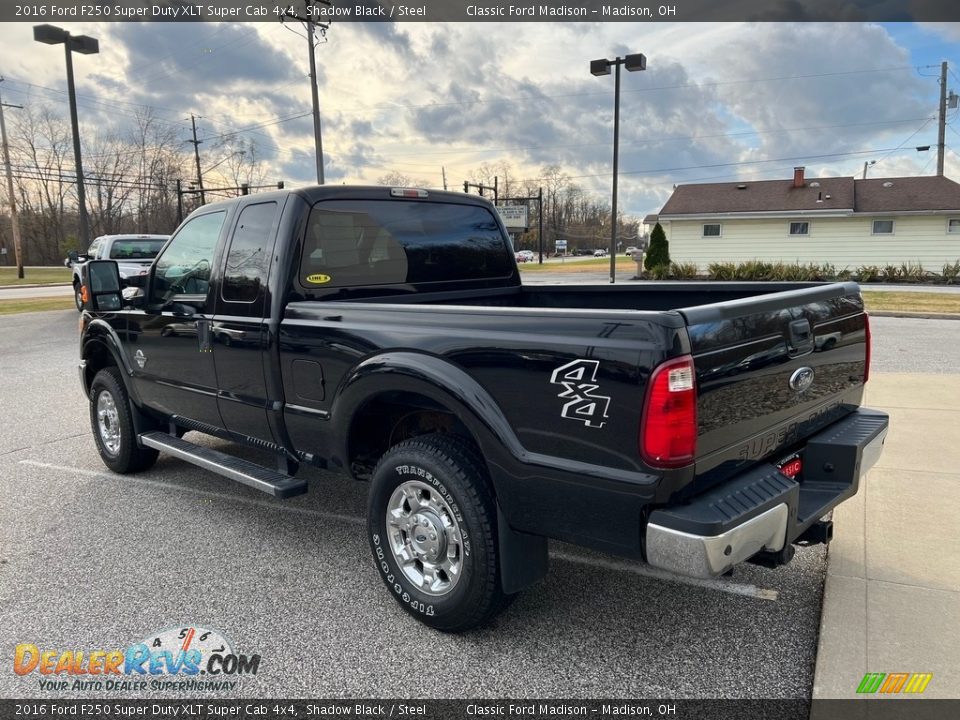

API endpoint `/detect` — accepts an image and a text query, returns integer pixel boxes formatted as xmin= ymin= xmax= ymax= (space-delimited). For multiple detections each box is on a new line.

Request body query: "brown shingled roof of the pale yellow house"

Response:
xmin=660 ymin=176 xmax=960 ymax=216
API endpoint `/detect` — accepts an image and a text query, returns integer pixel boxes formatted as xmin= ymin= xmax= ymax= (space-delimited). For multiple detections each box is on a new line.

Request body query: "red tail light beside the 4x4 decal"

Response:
xmin=640 ymin=355 xmax=697 ymax=468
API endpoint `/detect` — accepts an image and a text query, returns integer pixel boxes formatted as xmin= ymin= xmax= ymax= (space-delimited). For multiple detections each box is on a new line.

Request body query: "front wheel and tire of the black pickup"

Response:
xmin=90 ymin=367 xmax=159 ymax=474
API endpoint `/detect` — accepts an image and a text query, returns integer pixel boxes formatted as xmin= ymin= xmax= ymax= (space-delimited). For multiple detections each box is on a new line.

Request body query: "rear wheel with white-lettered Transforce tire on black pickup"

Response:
xmin=367 ymin=435 xmax=512 ymax=633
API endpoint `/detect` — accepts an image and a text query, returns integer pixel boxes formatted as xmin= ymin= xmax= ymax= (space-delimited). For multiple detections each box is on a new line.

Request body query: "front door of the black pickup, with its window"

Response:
xmin=127 ymin=210 xmax=227 ymax=427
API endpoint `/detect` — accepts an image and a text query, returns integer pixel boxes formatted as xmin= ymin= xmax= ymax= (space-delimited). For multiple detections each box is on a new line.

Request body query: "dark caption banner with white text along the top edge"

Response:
xmin=0 ymin=0 xmax=960 ymax=23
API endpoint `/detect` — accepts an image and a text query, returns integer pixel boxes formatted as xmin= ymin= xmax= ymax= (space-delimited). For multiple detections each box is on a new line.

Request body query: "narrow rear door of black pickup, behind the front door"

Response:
xmin=212 ymin=201 xmax=280 ymax=441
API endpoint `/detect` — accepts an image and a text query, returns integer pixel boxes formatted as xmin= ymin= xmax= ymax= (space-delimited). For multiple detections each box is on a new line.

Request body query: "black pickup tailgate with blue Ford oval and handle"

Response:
xmin=680 ymin=283 xmax=867 ymax=491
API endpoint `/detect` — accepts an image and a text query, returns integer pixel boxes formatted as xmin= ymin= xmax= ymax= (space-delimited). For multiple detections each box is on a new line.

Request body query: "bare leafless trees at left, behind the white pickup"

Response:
xmin=0 ymin=106 xmax=265 ymax=265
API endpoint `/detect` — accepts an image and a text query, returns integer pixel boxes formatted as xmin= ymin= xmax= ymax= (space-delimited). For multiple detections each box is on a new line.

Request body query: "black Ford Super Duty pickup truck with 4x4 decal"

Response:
xmin=80 ymin=186 xmax=887 ymax=631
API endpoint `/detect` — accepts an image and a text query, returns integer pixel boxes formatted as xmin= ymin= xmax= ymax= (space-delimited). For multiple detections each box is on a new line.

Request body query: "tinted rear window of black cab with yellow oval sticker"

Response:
xmin=300 ymin=200 xmax=513 ymax=288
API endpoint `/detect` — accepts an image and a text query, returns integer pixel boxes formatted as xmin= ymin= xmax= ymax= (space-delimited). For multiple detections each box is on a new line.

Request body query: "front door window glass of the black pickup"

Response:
xmin=150 ymin=211 xmax=226 ymax=303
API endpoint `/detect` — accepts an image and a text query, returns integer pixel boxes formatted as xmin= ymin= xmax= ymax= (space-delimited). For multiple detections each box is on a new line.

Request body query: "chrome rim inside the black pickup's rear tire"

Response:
xmin=387 ymin=480 xmax=463 ymax=596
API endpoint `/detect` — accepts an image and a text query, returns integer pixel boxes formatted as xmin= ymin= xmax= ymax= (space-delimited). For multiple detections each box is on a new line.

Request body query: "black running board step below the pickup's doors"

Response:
xmin=138 ymin=432 xmax=307 ymax=498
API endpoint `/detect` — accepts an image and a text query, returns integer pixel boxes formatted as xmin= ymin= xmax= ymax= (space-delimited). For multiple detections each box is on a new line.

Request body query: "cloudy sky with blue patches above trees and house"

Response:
xmin=0 ymin=22 xmax=960 ymax=217
